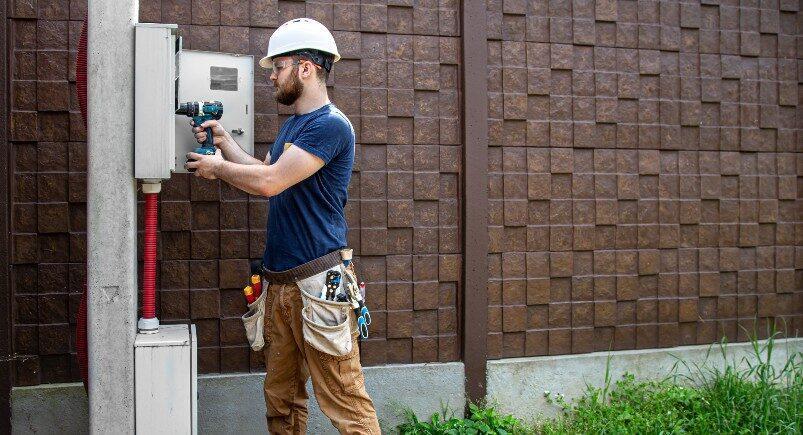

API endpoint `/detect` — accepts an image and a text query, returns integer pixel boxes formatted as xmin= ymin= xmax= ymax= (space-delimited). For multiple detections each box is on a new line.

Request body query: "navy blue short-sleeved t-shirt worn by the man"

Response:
xmin=262 ymin=103 xmax=354 ymax=272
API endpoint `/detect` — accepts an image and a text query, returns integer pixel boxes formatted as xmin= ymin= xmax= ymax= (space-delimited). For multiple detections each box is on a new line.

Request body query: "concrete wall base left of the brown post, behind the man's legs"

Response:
xmin=11 ymin=362 xmax=466 ymax=434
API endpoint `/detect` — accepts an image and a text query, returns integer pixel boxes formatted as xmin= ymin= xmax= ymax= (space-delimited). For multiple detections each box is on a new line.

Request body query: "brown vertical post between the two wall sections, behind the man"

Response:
xmin=460 ymin=0 xmax=488 ymax=408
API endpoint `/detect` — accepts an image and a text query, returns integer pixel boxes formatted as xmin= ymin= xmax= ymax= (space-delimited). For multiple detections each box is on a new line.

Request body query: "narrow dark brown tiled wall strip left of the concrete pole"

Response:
xmin=8 ymin=0 xmax=86 ymax=385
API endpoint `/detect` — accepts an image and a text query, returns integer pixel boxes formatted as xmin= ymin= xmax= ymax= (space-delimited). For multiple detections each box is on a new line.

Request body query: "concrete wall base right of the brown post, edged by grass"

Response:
xmin=488 ymin=338 xmax=803 ymax=421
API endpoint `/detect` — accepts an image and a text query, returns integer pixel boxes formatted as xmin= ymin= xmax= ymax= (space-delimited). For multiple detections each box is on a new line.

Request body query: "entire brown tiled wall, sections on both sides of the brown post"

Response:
xmin=3 ymin=0 xmax=803 ymax=385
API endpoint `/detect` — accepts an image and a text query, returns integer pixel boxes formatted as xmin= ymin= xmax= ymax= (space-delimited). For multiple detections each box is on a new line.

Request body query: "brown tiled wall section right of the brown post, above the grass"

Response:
xmin=487 ymin=0 xmax=803 ymax=358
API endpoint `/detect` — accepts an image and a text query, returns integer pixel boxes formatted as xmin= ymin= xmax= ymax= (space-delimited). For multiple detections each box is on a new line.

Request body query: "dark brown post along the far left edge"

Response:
xmin=0 ymin=2 xmax=13 ymax=433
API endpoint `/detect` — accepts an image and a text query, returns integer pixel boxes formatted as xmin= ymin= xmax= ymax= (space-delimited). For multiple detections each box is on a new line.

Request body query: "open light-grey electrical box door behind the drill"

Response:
xmin=174 ymin=50 xmax=254 ymax=172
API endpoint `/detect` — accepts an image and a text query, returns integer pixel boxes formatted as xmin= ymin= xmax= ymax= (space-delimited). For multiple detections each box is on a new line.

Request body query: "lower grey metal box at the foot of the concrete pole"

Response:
xmin=134 ymin=325 xmax=198 ymax=435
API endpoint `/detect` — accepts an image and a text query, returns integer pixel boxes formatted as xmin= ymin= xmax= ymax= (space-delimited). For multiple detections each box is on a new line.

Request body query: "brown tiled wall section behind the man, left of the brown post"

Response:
xmin=9 ymin=0 xmax=462 ymax=385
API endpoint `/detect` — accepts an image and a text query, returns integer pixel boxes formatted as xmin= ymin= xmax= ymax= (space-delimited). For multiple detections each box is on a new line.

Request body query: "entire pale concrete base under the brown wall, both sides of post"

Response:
xmin=11 ymin=338 xmax=803 ymax=435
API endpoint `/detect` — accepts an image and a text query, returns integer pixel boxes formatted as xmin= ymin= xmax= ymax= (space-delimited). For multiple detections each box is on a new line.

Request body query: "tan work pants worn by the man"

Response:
xmin=262 ymin=284 xmax=381 ymax=434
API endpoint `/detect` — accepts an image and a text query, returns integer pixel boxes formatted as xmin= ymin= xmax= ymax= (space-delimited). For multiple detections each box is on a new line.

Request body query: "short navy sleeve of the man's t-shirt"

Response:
xmin=293 ymin=115 xmax=354 ymax=163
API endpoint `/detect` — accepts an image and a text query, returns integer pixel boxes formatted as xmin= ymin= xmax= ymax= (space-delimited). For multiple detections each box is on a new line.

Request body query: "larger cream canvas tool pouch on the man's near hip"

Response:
xmin=301 ymin=291 xmax=353 ymax=356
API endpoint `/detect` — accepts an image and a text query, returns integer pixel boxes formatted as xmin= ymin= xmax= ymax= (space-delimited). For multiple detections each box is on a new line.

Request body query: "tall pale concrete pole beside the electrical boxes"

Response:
xmin=87 ymin=0 xmax=139 ymax=433
